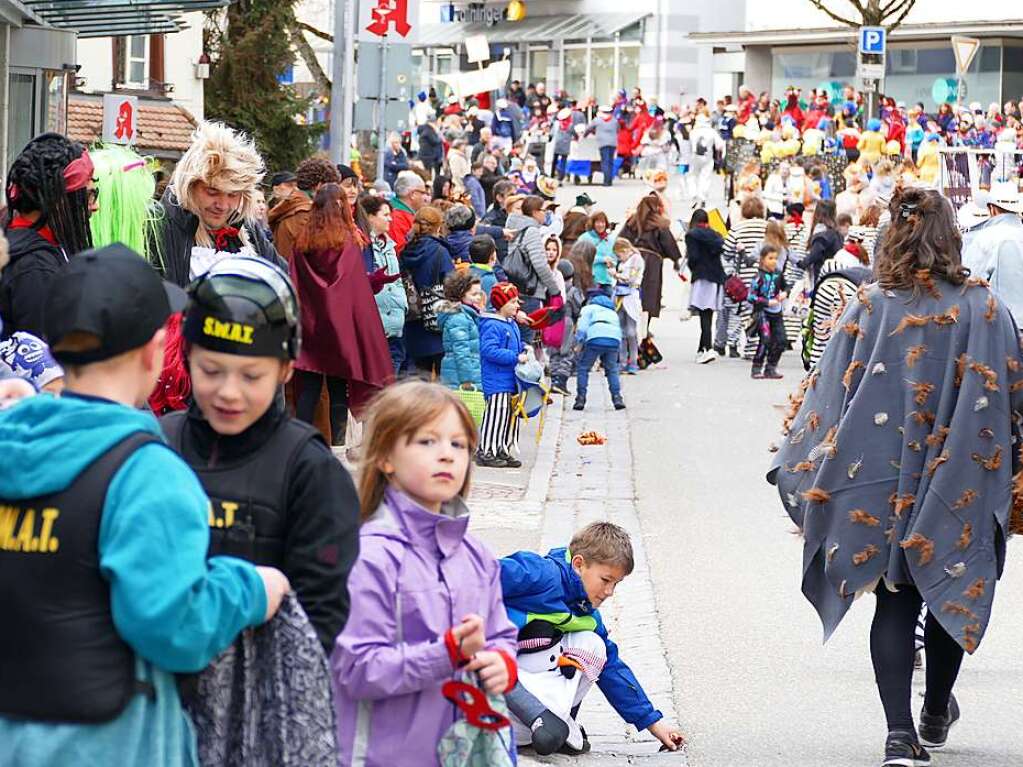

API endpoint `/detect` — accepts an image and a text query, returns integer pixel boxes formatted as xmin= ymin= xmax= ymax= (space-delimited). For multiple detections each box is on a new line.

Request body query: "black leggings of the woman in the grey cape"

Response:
xmin=871 ymin=581 xmax=963 ymax=732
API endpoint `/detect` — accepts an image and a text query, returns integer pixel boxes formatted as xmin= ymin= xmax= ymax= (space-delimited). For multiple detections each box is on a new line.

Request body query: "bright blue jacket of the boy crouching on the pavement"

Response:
xmin=501 ymin=547 xmax=663 ymax=730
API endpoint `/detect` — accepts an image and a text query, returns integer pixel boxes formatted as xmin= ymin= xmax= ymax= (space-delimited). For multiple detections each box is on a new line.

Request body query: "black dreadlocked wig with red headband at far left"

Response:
xmin=6 ymin=133 xmax=92 ymax=256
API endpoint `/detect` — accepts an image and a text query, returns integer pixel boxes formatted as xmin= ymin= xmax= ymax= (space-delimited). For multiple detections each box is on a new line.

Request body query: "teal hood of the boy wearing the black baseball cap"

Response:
xmin=0 ymin=395 xmax=163 ymax=500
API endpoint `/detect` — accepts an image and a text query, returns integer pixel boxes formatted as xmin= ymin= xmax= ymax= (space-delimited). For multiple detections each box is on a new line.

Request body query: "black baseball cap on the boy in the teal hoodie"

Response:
xmin=44 ymin=242 xmax=188 ymax=365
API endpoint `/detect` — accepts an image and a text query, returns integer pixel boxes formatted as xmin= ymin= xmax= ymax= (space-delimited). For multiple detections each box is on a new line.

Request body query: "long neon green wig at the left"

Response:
xmin=89 ymin=144 xmax=163 ymax=265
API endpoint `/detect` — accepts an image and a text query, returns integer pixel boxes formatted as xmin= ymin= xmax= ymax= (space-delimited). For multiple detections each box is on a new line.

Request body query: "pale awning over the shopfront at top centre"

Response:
xmin=415 ymin=13 xmax=650 ymax=48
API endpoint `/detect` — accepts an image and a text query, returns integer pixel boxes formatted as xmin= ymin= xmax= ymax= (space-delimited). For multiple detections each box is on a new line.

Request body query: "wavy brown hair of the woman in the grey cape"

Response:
xmin=875 ymin=188 xmax=970 ymax=292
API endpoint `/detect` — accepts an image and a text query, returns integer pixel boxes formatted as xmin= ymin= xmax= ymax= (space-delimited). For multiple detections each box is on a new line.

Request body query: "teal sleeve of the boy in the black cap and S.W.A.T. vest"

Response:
xmin=99 ymin=445 xmax=266 ymax=672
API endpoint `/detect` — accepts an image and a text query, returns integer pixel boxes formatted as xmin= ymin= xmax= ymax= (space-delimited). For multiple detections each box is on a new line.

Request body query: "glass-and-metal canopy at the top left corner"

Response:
xmin=21 ymin=0 xmax=230 ymax=38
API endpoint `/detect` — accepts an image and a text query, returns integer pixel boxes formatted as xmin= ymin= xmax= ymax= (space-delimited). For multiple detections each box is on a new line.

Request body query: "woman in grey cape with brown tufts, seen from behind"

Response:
xmin=768 ymin=189 xmax=1023 ymax=767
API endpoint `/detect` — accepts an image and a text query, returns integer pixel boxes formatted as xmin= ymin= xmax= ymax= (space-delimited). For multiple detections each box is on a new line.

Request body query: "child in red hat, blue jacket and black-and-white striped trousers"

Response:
xmin=476 ymin=282 xmax=528 ymax=468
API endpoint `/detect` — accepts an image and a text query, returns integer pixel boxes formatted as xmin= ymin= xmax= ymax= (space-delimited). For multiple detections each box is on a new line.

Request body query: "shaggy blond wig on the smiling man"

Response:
xmin=170 ymin=122 xmax=266 ymax=247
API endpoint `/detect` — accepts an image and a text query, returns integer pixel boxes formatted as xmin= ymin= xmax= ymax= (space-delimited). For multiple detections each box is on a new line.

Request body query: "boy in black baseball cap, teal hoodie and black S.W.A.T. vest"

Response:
xmin=0 ymin=244 xmax=290 ymax=767
